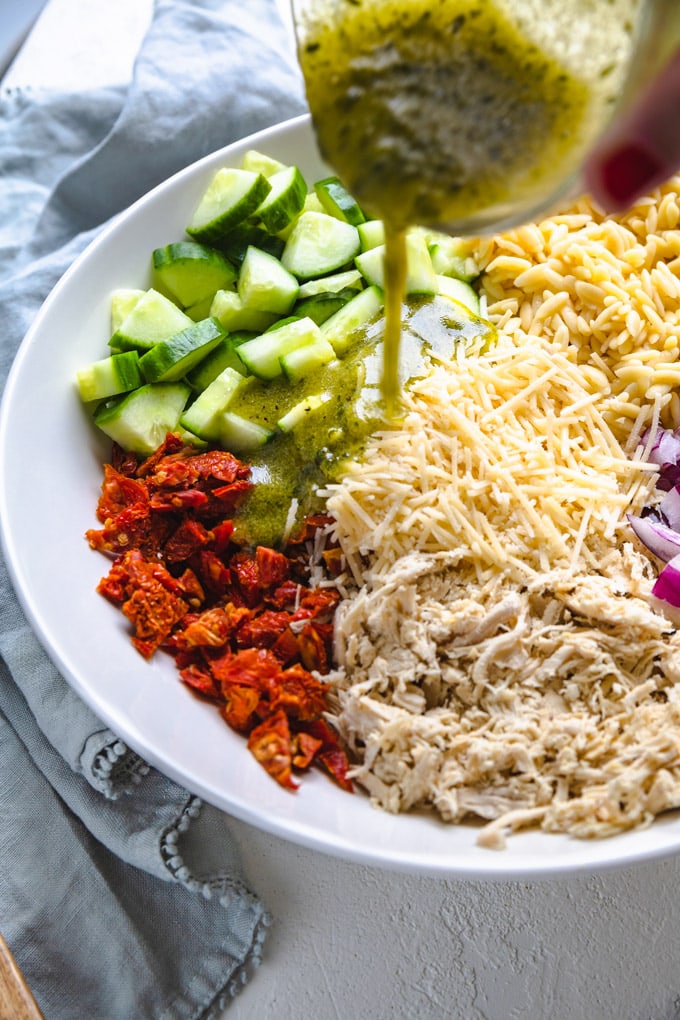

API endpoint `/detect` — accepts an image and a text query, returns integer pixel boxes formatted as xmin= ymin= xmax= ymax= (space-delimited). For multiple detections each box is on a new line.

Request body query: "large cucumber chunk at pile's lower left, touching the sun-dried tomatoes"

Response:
xmin=94 ymin=383 xmax=191 ymax=456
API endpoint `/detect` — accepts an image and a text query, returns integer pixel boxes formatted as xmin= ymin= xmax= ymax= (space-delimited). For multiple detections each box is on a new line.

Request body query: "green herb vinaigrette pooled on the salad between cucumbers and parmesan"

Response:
xmin=234 ymin=296 xmax=495 ymax=546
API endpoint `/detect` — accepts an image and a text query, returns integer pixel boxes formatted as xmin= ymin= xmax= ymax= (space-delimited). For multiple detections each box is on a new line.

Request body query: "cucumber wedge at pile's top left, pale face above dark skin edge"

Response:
xmin=187 ymin=167 xmax=271 ymax=245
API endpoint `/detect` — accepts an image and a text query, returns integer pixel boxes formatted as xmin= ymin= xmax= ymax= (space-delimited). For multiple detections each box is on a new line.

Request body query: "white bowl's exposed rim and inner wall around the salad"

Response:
xmin=0 ymin=116 xmax=680 ymax=878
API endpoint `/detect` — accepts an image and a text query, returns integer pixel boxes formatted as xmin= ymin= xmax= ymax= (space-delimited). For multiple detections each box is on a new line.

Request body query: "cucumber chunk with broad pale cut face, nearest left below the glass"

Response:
xmin=281 ymin=212 xmax=361 ymax=279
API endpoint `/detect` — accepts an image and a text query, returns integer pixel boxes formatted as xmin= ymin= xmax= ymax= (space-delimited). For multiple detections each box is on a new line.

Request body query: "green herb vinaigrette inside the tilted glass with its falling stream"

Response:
xmin=299 ymin=0 xmax=611 ymax=416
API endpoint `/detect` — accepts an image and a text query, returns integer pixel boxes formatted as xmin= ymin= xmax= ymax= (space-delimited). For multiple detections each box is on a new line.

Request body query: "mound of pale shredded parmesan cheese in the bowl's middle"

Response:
xmin=327 ymin=334 xmax=657 ymax=581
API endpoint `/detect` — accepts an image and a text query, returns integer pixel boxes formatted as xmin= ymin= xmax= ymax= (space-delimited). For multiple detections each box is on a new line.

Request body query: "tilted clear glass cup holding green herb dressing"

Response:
xmin=292 ymin=0 xmax=680 ymax=235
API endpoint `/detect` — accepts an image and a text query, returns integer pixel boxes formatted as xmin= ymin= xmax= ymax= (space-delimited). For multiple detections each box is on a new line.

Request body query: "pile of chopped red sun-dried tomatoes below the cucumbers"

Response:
xmin=87 ymin=434 xmax=352 ymax=791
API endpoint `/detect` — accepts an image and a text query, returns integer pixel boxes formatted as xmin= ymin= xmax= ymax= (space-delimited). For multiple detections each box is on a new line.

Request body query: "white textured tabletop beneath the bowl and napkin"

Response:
xmin=0 ymin=0 xmax=680 ymax=1020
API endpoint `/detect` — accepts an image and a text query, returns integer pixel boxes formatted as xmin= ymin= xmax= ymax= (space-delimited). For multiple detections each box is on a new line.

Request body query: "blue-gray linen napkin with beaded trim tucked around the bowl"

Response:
xmin=0 ymin=0 xmax=305 ymax=1020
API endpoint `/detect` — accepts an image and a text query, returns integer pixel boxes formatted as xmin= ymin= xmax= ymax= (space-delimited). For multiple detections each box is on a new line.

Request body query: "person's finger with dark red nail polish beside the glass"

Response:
xmin=585 ymin=49 xmax=680 ymax=212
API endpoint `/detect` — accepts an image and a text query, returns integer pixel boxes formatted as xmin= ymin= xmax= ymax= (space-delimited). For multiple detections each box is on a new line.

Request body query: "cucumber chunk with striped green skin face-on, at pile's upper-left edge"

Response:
xmin=152 ymin=241 xmax=237 ymax=308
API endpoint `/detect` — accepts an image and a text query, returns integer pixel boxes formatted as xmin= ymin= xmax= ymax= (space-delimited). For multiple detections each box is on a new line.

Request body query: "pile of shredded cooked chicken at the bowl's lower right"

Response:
xmin=326 ymin=545 xmax=680 ymax=849
